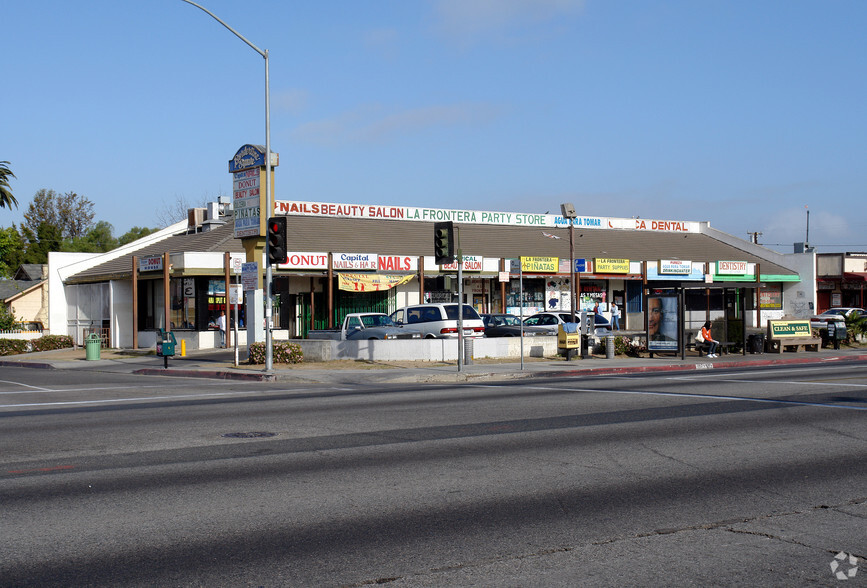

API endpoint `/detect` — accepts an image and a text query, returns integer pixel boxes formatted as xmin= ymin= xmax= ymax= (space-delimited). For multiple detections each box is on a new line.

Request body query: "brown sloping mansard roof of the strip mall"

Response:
xmin=68 ymin=216 xmax=795 ymax=282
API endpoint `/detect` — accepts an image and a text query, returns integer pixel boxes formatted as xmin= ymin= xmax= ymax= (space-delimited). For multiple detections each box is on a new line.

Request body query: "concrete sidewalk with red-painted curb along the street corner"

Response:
xmin=6 ymin=347 xmax=867 ymax=384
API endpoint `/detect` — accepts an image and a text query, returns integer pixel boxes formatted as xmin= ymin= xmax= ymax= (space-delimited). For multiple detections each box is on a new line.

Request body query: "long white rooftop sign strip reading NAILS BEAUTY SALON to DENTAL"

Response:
xmin=274 ymin=200 xmax=700 ymax=233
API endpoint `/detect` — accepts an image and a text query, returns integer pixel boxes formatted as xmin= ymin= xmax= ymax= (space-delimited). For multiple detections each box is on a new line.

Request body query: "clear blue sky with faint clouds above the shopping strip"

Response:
xmin=0 ymin=0 xmax=867 ymax=252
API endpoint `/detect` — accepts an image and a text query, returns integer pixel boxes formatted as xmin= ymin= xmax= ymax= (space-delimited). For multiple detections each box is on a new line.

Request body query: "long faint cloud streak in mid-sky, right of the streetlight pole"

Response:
xmin=292 ymin=104 xmax=502 ymax=145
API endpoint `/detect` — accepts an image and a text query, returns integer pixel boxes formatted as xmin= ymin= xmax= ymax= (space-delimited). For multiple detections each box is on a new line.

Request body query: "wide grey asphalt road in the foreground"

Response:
xmin=0 ymin=362 xmax=867 ymax=586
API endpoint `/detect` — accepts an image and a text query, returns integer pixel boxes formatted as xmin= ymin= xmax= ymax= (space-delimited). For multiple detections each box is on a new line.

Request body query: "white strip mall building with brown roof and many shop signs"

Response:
xmin=49 ymin=201 xmax=816 ymax=348
